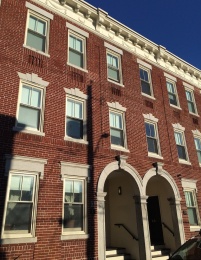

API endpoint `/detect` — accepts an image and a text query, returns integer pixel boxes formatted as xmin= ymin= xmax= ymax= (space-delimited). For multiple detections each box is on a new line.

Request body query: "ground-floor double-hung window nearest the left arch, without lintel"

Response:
xmin=63 ymin=179 xmax=84 ymax=231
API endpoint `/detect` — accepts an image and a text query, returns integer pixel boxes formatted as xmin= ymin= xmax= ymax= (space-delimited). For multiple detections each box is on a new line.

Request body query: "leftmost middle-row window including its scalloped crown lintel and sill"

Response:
xmin=14 ymin=73 xmax=49 ymax=134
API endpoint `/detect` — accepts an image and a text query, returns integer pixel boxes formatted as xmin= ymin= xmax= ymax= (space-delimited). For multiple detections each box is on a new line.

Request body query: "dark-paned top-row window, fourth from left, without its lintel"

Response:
xmin=140 ymin=67 xmax=153 ymax=96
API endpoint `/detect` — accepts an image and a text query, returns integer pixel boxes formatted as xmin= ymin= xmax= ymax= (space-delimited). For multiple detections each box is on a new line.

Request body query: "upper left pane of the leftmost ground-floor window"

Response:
xmin=9 ymin=175 xmax=22 ymax=201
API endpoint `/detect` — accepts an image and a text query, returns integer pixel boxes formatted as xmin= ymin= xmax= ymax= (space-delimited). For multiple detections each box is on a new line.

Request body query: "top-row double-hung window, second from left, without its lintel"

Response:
xmin=68 ymin=32 xmax=86 ymax=69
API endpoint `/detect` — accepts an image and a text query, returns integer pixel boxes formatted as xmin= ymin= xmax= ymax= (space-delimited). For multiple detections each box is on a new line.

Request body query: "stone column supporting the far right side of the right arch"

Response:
xmin=168 ymin=198 xmax=185 ymax=248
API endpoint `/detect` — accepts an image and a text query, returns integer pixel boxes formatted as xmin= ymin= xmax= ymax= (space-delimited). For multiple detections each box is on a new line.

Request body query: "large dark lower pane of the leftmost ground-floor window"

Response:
xmin=5 ymin=202 xmax=32 ymax=233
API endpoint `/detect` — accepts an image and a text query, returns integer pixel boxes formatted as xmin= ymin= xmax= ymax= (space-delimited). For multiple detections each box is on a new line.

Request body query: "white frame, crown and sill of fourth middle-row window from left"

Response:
xmin=143 ymin=114 xmax=163 ymax=159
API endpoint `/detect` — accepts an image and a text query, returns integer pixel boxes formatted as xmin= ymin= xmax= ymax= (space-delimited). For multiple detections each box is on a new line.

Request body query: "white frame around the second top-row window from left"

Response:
xmin=67 ymin=29 xmax=87 ymax=72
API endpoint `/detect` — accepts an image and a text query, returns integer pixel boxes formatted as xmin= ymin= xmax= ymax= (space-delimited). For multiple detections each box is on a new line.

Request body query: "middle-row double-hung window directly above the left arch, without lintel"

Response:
xmin=110 ymin=111 xmax=124 ymax=147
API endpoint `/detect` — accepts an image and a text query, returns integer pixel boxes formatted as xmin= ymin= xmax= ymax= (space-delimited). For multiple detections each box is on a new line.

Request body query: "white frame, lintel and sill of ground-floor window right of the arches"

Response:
xmin=181 ymin=178 xmax=201 ymax=232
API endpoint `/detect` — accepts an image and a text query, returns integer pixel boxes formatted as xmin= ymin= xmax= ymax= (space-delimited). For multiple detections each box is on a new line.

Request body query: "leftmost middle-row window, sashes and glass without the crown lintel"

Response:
xmin=17 ymin=84 xmax=43 ymax=131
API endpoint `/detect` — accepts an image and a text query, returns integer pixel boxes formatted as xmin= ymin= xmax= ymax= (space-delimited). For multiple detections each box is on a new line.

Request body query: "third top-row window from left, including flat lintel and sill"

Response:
xmin=104 ymin=42 xmax=123 ymax=84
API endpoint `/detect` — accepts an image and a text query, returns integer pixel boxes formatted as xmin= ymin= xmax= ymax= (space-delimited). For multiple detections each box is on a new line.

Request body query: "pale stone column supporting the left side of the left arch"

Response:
xmin=97 ymin=192 xmax=107 ymax=260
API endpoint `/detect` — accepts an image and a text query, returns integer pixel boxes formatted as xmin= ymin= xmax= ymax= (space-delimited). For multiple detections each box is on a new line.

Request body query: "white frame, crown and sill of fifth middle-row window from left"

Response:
xmin=172 ymin=123 xmax=191 ymax=164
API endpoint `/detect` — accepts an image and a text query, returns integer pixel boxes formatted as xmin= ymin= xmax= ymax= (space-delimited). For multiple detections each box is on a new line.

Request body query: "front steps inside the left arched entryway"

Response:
xmin=106 ymin=248 xmax=132 ymax=260
